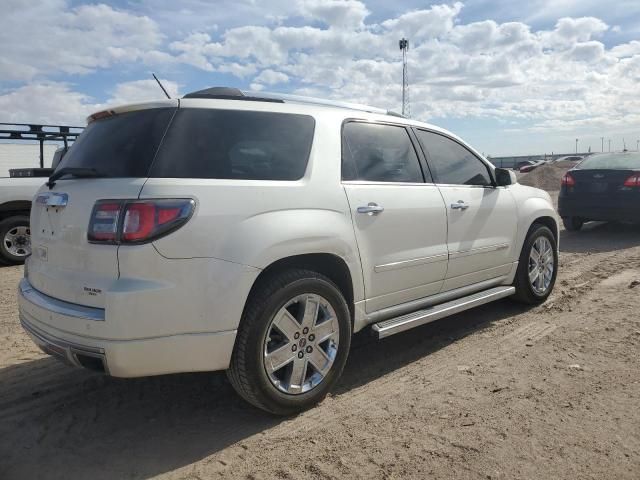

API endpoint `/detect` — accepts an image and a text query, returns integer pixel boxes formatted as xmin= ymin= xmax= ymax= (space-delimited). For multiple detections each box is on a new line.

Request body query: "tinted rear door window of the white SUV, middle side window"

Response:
xmin=342 ymin=122 xmax=424 ymax=183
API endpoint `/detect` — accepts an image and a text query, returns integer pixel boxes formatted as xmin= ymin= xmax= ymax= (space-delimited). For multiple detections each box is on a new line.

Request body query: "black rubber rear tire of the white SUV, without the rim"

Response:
xmin=227 ymin=270 xmax=352 ymax=415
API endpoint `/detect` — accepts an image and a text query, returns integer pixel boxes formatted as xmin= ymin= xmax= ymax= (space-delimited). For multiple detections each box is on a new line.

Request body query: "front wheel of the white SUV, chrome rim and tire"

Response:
xmin=514 ymin=224 xmax=558 ymax=305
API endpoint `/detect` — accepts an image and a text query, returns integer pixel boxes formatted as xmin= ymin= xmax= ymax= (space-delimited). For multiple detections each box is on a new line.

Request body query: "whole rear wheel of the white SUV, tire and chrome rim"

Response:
xmin=227 ymin=270 xmax=351 ymax=415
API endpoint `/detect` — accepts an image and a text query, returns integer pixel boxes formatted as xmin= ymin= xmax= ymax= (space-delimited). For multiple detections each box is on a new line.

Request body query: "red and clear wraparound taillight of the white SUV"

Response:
xmin=87 ymin=199 xmax=195 ymax=244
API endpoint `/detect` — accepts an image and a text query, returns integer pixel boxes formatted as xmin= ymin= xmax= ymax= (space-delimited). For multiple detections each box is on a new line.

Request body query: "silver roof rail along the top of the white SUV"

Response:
xmin=183 ymin=87 xmax=405 ymax=118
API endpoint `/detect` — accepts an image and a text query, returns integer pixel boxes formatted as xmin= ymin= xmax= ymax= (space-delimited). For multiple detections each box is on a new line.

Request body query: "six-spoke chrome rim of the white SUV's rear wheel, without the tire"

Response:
xmin=264 ymin=293 xmax=340 ymax=395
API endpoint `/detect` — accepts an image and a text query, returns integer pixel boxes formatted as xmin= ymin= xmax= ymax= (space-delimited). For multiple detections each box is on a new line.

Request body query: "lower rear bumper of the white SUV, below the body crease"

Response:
xmin=18 ymin=279 xmax=236 ymax=377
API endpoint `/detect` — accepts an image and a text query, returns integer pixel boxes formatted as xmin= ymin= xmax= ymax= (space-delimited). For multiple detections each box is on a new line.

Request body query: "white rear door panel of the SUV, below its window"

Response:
xmin=344 ymin=182 xmax=447 ymax=313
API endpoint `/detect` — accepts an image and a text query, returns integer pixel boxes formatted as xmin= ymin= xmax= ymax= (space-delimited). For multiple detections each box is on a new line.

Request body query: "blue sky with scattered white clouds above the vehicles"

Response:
xmin=0 ymin=0 xmax=640 ymax=156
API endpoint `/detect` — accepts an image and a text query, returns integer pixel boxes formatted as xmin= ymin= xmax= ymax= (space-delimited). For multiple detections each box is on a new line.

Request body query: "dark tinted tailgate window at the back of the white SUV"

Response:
xmin=58 ymin=108 xmax=176 ymax=177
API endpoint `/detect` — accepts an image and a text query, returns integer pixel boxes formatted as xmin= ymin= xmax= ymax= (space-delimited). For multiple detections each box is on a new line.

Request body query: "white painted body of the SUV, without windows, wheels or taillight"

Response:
xmin=20 ymin=95 xmax=556 ymax=376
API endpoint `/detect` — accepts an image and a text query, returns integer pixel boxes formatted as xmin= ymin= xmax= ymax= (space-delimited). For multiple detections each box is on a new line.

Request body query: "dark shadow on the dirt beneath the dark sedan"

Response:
xmin=560 ymin=222 xmax=640 ymax=253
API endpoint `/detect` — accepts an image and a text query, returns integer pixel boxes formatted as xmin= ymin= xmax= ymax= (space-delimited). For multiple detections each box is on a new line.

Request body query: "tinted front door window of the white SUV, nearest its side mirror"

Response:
xmin=416 ymin=130 xmax=492 ymax=186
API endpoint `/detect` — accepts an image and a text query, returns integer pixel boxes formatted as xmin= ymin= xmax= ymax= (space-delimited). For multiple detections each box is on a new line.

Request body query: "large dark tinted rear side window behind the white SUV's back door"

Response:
xmin=149 ymin=108 xmax=315 ymax=180
